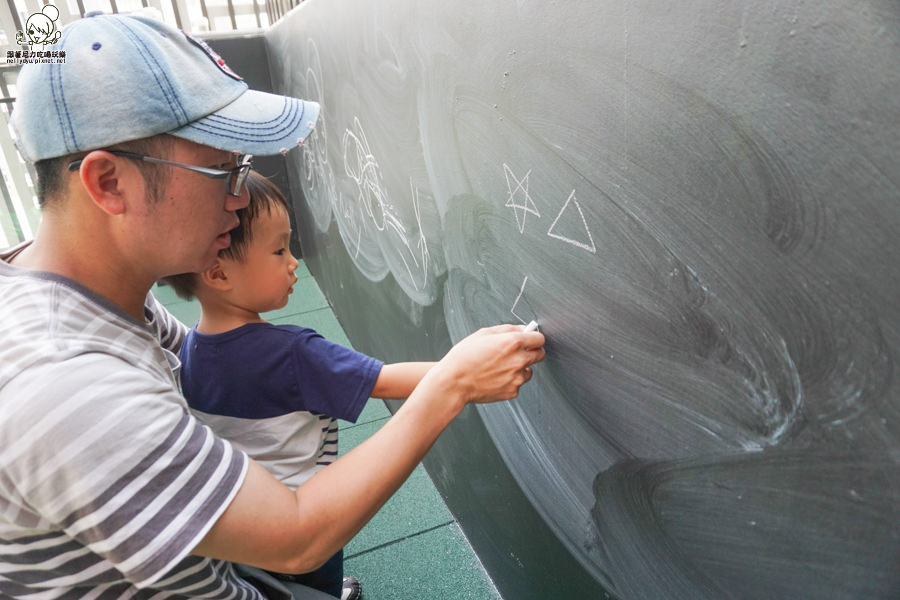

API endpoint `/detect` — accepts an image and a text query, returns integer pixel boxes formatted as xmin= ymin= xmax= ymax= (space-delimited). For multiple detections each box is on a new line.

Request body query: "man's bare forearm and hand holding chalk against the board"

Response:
xmin=194 ymin=325 xmax=544 ymax=573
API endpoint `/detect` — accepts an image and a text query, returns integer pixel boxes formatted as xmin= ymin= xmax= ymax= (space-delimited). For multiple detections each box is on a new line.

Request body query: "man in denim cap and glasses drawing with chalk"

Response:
xmin=0 ymin=15 xmax=544 ymax=598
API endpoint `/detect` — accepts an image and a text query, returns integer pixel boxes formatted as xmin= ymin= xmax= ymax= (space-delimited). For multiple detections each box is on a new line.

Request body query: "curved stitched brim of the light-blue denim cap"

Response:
xmin=169 ymin=90 xmax=319 ymax=156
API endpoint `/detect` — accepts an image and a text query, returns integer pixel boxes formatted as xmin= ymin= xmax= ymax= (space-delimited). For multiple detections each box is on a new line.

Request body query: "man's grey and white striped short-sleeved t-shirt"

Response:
xmin=0 ymin=245 xmax=261 ymax=599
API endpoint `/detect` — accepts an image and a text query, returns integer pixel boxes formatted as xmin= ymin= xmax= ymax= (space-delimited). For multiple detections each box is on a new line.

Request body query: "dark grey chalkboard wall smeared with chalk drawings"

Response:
xmin=266 ymin=0 xmax=900 ymax=600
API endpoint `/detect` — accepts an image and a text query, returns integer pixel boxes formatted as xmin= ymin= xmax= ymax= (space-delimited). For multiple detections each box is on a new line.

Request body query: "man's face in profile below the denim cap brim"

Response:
xmin=132 ymin=138 xmax=249 ymax=277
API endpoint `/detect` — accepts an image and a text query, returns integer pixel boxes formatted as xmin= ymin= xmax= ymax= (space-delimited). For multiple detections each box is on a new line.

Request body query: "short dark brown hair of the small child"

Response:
xmin=162 ymin=170 xmax=291 ymax=300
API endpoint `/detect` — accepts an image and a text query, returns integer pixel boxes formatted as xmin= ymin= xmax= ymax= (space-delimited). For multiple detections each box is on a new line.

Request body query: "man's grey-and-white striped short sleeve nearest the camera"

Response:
xmin=0 ymin=353 xmax=248 ymax=587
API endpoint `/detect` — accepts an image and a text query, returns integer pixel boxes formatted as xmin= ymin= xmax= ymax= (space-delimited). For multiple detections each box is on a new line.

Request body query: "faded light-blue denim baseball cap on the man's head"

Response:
xmin=11 ymin=15 xmax=319 ymax=162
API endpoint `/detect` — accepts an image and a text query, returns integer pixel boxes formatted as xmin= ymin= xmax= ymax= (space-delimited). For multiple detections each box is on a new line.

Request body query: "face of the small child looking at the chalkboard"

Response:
xmin=224 ymin=207 xmax=298 ymax=313
